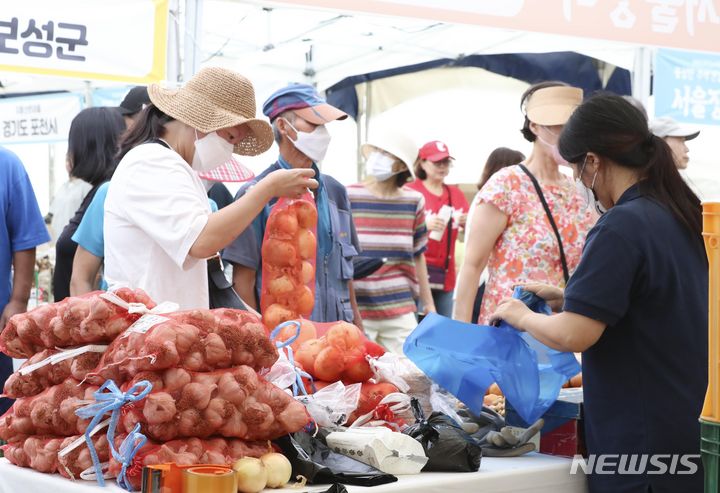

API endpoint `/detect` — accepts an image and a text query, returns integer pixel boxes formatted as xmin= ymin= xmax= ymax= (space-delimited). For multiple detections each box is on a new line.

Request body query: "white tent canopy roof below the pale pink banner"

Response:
xmin=198 ymin=0 xmax=636 ymax=97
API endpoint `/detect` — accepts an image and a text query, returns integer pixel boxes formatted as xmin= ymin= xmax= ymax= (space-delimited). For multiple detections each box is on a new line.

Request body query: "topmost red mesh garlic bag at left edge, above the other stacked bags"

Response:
xmin=0 ymin=288 xmax=155 ymax=358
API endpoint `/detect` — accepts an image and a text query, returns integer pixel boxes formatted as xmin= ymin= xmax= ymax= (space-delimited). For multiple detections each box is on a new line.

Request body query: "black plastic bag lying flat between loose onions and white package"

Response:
xmin=274 ymin=431 xmax=397 ymax=486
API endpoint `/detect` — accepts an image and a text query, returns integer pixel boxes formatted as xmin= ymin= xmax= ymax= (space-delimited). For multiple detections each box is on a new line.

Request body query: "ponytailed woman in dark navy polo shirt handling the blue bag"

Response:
xmin=493 ymin=94 xmax=708 ymax=493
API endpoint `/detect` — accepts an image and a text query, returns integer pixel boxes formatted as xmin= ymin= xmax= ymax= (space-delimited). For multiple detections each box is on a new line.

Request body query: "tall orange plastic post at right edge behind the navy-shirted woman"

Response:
xmin=701 ymin=202 xmax=720 ymax=420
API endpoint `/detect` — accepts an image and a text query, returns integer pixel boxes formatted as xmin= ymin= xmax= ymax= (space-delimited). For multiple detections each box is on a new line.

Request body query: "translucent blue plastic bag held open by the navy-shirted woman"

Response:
xmin=403 ymin=288 xmax=580 ymax=423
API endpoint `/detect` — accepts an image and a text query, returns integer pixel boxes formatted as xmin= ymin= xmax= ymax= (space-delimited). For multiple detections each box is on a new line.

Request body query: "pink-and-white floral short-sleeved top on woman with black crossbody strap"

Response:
xmin=473 ymin=166 xmax=597 ymax=324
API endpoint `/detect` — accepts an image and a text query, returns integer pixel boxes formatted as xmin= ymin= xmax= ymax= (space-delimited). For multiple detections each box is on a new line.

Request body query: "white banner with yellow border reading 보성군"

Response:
xmin=0 ymin=0 xmax=168 ymax=83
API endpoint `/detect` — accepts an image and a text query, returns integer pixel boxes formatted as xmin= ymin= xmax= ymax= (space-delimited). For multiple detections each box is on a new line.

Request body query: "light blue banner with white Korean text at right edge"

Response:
xmin=653 ymin=50 xmax=720 ymax=125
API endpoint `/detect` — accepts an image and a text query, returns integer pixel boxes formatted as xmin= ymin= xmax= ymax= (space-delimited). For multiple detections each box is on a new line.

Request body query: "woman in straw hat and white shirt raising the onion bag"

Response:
xmin=104 ymin=67 xmax=317 ymax=309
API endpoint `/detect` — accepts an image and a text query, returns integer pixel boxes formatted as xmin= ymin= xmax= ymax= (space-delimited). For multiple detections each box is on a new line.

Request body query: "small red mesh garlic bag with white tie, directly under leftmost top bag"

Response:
xmin=3 ymin=346 xmax=104 ymax=399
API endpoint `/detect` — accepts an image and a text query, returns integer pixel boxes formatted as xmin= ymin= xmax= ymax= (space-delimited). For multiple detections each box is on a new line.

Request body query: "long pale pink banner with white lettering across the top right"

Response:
xmin=275 ymin=0 xmax=720 ymax=52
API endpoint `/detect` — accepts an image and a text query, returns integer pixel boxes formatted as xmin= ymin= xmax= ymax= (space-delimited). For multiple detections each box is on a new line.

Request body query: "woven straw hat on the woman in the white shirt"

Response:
xmin=148 ymin=67 xmax=273 ymax=156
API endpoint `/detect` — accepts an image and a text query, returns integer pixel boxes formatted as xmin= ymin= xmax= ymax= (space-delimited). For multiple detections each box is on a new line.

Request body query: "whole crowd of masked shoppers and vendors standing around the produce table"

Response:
xmin=0 ymin=68 xmax=708 ymax=491
